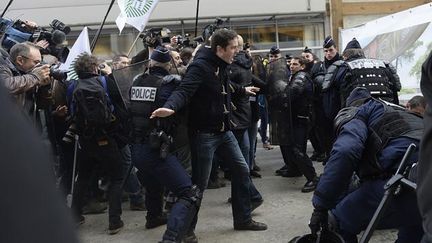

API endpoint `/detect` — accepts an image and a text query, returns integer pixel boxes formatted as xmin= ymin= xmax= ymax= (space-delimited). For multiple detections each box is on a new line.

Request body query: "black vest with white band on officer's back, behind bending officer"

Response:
xmin=341 ymin=58 xmax=395 ymax=102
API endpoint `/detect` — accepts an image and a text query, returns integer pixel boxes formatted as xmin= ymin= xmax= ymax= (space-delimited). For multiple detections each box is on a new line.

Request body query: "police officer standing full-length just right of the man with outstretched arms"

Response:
xmin=277 ymin=57 xmax=317 ymax=192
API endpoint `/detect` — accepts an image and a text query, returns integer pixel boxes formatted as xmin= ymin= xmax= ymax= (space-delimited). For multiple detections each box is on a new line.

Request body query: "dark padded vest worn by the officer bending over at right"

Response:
xmin=359 ymin=101 xmax=424 ymax=178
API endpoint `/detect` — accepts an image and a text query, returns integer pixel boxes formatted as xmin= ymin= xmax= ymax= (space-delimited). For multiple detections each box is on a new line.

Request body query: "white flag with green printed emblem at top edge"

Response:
xmin=116 ymin=0 xmax=159 ymax=33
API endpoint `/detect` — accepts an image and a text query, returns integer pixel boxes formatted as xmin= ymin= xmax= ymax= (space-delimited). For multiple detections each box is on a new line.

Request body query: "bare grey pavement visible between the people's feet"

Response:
xmin=79 ymin=143 xmax=397 ymax=243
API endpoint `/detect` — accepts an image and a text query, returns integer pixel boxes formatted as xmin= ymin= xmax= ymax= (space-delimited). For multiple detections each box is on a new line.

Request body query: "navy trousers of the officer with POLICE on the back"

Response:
xmin=132 ymin=144 xmax=195 ymax=239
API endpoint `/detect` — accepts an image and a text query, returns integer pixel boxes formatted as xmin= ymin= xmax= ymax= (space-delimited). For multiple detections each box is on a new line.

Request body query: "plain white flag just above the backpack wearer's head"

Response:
xmin=60 ymin=27 xmax=91 ymax=80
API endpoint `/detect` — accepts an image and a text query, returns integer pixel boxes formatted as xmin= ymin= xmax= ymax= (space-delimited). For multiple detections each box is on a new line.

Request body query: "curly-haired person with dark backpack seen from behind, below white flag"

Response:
xmin=68 ymin=54 xmax=123 ymax=234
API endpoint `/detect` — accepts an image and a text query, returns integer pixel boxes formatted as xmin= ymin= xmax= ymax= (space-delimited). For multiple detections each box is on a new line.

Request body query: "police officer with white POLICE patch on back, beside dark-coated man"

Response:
xmin=130 ymin=47 xmax=202 ymax=242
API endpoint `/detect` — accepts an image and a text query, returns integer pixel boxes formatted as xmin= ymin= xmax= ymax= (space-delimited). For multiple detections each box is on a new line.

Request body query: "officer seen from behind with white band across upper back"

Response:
xmin=323 ymin=38 xmax=401 ymax=123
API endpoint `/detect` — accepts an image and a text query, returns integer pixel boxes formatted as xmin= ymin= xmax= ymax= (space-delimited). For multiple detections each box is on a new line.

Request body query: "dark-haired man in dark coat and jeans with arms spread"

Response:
xmin=152 ymin=30 xmax=267 ymax=240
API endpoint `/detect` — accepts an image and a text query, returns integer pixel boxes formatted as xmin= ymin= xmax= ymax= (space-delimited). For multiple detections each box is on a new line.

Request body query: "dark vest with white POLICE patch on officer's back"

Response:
xmin=129 ymin=74 xmax=175 ymax=143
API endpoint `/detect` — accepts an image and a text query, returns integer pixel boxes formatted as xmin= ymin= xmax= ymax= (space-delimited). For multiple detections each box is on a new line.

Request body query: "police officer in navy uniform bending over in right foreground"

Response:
xmin=309 ymin=87 xmax=423 ymax=242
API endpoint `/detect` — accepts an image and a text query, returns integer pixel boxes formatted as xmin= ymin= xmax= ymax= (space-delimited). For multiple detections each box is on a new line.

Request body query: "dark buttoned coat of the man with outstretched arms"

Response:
xmin=163 ymin=47 xmax=244 ymax=132
